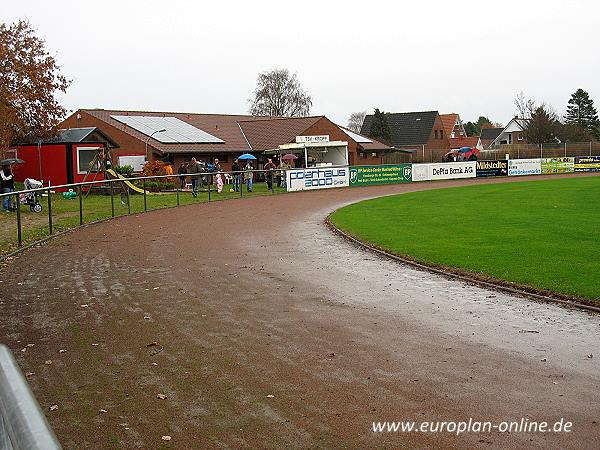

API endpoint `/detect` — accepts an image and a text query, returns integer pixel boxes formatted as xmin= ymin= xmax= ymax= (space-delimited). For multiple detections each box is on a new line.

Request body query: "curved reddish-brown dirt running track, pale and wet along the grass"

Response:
xmin=0 ymin=177 xmax=600 ymax=449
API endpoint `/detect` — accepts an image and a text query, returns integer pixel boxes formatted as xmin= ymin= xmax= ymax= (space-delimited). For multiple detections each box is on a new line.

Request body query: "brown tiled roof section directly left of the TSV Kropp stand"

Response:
xmin=239 ymin=116 xmax=325 ymax=151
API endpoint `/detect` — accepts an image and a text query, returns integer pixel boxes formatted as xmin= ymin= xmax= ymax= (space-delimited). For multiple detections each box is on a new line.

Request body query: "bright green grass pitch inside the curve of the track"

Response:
xmin=331 ymin=177 xmax=600 ymax=304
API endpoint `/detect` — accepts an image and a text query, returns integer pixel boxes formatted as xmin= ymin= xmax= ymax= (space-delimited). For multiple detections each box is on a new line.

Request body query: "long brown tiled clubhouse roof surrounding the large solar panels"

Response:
xmin=81 ymin=109 xmax=262 ymax=153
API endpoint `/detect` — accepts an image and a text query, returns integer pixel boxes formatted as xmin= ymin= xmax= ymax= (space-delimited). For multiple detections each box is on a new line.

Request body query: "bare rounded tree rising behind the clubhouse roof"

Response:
xmin=248 ymin=69 xmax=312 ymax=117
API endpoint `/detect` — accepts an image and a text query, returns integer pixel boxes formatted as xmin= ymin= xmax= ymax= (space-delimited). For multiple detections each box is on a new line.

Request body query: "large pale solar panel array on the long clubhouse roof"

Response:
xmin=110 ymin=116 xmax=225 ymax=144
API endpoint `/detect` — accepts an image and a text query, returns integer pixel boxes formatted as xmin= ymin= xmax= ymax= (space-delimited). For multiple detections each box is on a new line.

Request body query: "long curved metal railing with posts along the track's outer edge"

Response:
xmin=0 ymin=169 xmax=284 ymax=254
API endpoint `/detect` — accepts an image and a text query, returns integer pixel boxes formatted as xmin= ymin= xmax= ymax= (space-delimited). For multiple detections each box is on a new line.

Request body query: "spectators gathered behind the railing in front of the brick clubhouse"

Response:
xmin=177 ymin=158 xmax=291 ymax=197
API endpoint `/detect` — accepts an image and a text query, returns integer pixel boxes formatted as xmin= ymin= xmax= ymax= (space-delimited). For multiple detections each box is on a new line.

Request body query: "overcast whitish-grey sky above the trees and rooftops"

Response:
xmin=0 ymin=0 xmax=600 ymax=125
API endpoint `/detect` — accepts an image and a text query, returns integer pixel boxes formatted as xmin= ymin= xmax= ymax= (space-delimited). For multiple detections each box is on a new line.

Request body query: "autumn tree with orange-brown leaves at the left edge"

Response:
xmin=0 ymin=20 xmax=71 ymax=153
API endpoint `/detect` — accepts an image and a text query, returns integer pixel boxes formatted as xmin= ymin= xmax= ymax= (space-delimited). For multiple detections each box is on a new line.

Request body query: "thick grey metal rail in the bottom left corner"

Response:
xmin=0 ymin=344 xmax=61 ymax=450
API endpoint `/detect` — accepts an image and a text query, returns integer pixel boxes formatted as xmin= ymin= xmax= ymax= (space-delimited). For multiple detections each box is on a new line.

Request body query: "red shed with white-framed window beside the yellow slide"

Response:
xmin=13 ymin=127 xmax=118 ymax=186
